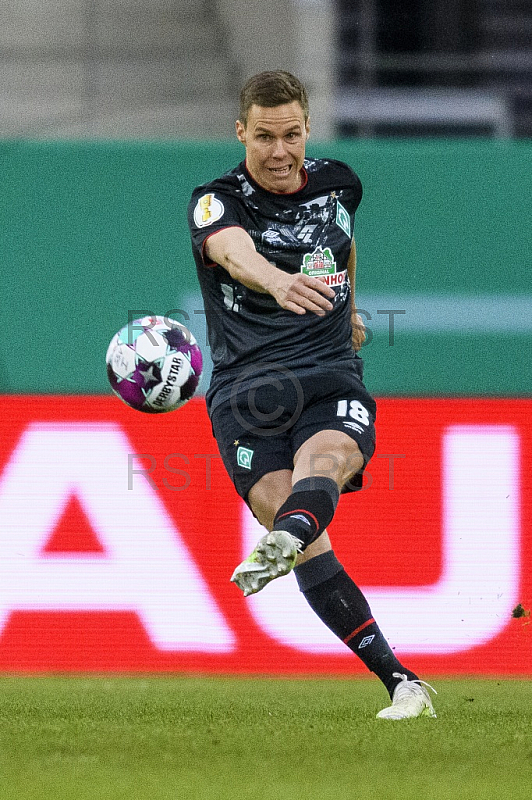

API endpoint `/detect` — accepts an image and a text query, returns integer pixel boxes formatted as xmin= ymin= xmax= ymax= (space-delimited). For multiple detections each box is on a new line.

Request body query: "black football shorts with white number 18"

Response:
xmin=211 ymin=371 xmax=376 ymax=501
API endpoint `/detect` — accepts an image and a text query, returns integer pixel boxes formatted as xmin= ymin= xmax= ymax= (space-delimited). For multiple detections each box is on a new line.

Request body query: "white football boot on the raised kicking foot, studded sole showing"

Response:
xmin=231 ymin=531 xmax=303 ymax=597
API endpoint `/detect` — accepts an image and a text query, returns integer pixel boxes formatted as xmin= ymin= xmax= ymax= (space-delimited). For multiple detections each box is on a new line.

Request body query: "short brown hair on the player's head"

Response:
xmin=239 ymin=70 xmax=309 ymax=127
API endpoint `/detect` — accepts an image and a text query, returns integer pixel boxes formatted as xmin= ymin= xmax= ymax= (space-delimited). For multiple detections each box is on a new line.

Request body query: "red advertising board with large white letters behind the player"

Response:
xmin=0 ymin=396 xmax=532 ymax=676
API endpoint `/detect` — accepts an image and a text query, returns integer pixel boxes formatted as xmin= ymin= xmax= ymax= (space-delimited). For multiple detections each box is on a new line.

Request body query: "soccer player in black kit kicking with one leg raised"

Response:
xmin=188 ymin=71 xmax=436 ymax=720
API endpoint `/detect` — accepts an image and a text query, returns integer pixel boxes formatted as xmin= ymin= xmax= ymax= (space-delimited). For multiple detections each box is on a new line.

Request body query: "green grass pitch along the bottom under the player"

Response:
xmin=0 ymin=676 xmax=532 ymax=800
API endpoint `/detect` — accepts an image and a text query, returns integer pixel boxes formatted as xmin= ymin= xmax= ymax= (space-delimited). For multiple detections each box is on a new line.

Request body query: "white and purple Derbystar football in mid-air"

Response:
xmin=106 ymin=316 xmax=203 ymax=414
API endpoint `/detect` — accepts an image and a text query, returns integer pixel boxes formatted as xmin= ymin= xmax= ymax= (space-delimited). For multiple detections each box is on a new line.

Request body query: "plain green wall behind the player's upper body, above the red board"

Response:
xmin=0 ymin=140 xmax=532 ymax=396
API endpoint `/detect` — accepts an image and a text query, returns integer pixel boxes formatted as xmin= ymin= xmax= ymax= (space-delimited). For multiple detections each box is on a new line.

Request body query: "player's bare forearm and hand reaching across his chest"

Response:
xmin=204 ymin=227 xmax=334 ymax=316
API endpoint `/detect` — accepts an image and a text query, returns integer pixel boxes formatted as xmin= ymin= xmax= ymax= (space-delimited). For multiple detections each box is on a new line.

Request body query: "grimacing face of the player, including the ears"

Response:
xmin=236 ymin=100 xmax=309 ymax=194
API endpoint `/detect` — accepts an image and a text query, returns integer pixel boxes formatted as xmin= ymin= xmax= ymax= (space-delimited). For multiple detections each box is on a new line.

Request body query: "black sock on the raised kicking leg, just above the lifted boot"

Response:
xmin=273 ymin=476 xmax=340 ymax=550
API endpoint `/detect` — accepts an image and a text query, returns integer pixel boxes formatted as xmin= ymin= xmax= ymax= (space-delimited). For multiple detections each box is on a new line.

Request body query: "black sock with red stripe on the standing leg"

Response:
xmin=294 ymin=550 xmax=417 ymax=697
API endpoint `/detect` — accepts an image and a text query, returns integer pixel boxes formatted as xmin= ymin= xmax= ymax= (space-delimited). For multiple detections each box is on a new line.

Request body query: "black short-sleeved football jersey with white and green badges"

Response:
xmin=188 ymin=159 xmax=362 ymax=408
